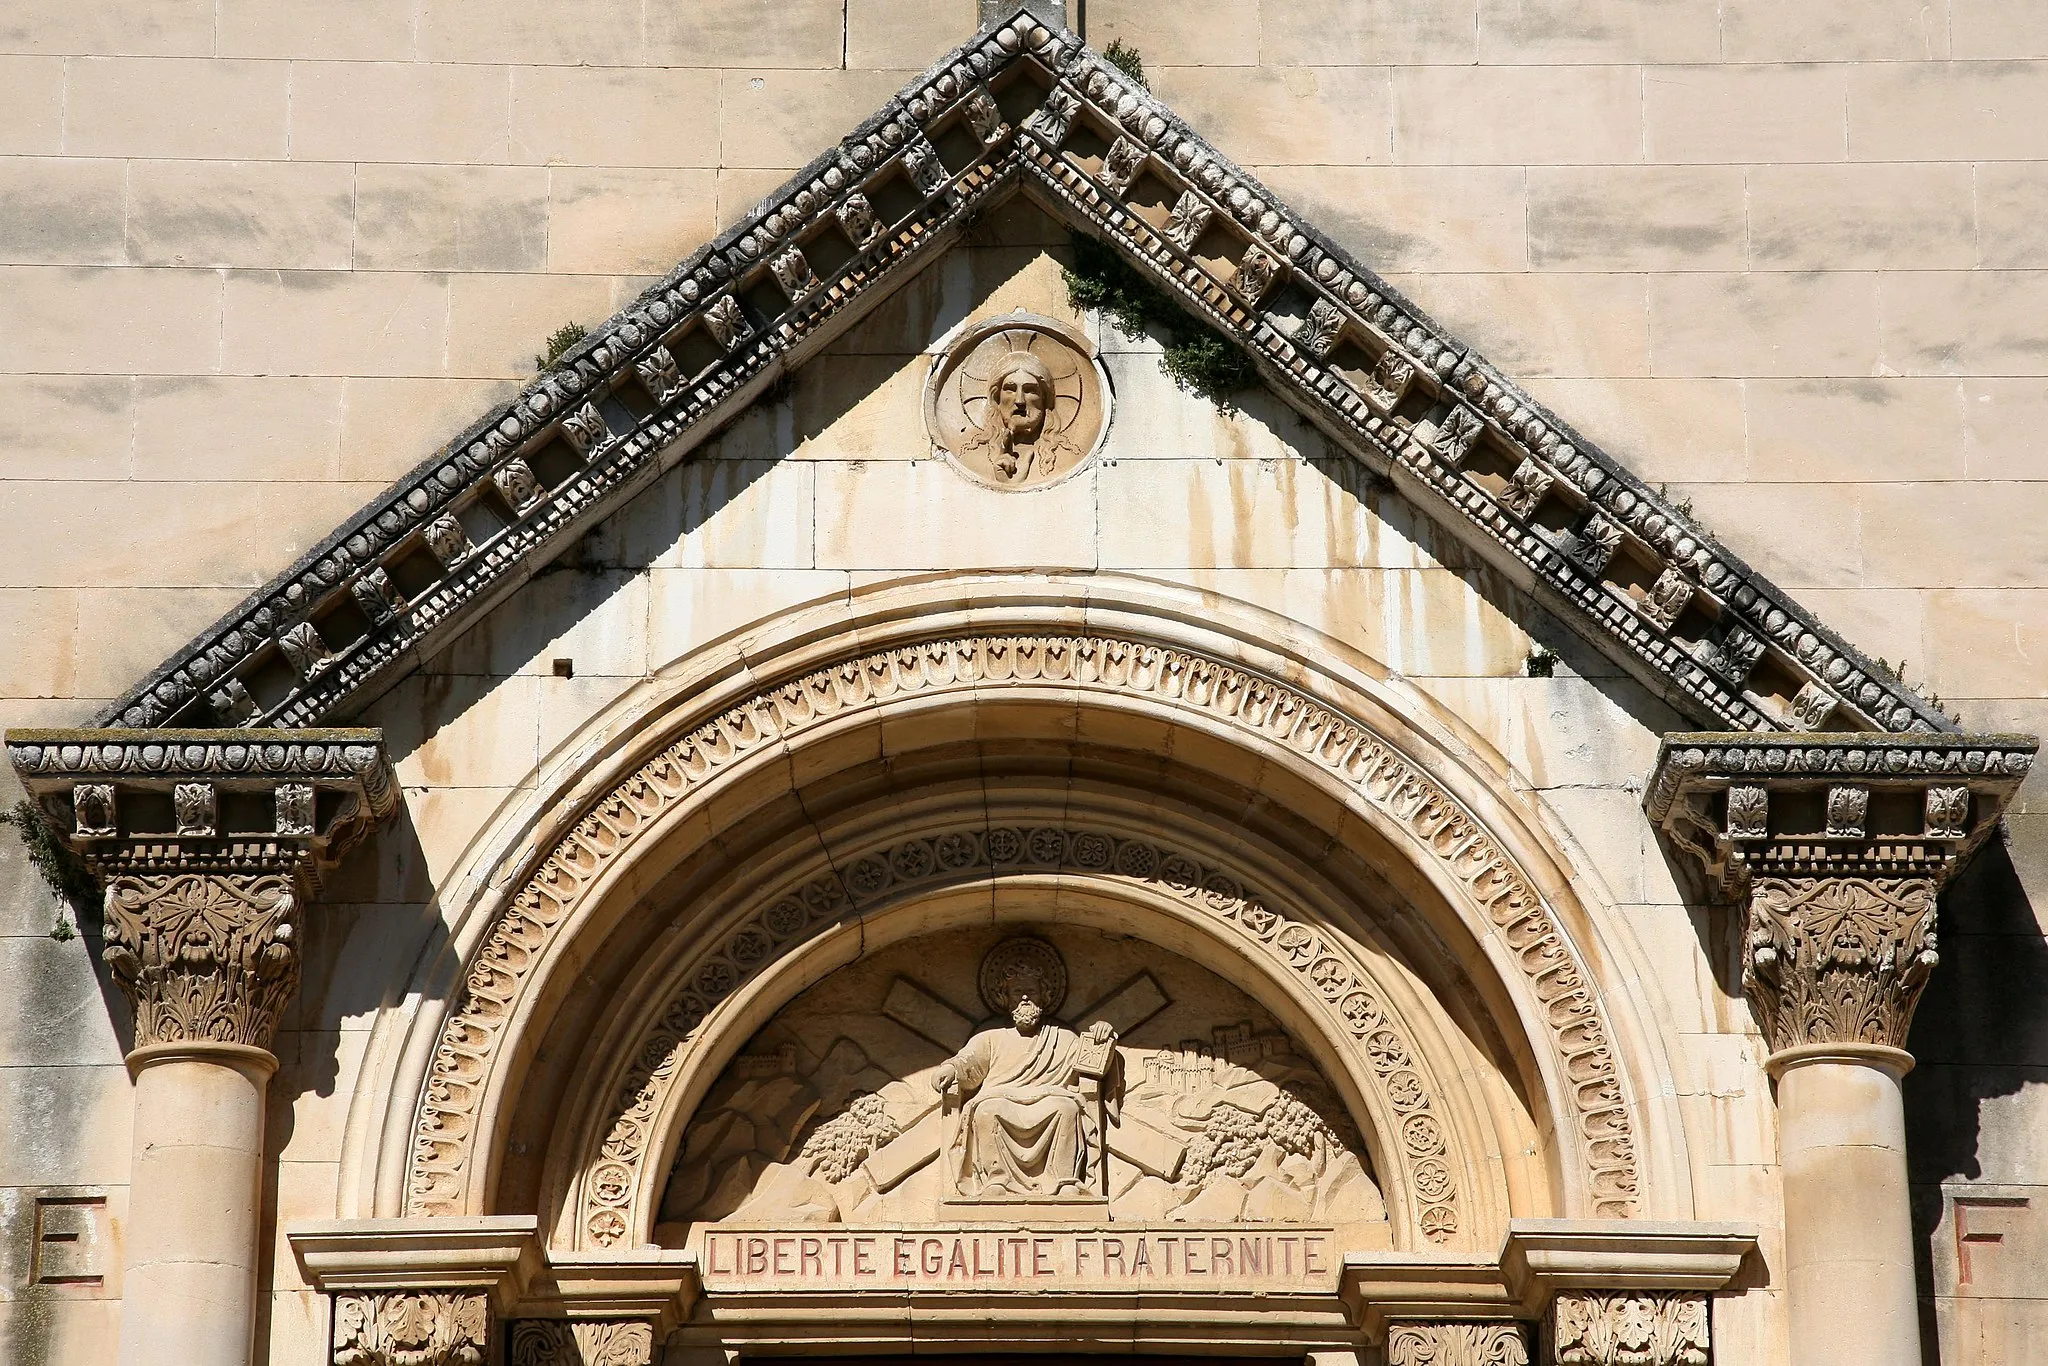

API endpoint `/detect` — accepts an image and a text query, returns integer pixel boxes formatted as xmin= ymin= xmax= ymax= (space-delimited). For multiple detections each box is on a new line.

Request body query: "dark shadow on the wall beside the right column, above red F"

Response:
xmin=1905 ymin=838 xmax=2048 ymax=1366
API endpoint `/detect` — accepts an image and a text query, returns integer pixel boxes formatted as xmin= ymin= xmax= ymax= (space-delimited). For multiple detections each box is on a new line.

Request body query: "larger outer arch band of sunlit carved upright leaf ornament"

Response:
xmin=403 ymin=633 xmax=1638 ymax=1216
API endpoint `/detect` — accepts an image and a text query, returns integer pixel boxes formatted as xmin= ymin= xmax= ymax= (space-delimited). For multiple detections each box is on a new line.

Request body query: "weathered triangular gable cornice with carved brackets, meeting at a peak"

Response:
xmin=98 ymin=8 xmax=1954 ymax=731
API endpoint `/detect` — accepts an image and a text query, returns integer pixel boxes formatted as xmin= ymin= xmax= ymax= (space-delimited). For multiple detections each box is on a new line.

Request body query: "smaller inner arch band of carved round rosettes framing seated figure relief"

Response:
xmin=573 ymin=825 xmax=1468 ymax=1247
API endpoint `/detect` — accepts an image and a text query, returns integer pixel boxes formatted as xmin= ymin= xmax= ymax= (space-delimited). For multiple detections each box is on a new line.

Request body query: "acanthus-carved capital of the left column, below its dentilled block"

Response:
xmin=106 ymin=872 xmax=299 ymax=1049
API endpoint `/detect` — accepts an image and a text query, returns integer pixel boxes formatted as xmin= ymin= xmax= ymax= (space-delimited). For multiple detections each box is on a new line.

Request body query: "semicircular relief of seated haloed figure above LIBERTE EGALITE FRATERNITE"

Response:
xmin=657 ymin=928 xmax=1386 ymax=1245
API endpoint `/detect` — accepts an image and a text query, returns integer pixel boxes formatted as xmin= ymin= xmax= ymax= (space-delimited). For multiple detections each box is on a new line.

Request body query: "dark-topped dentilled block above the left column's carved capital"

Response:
xmin=6 ymin=727 xmax=397 ymax=885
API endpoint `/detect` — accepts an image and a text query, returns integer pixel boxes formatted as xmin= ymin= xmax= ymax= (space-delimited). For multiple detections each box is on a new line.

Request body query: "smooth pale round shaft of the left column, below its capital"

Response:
xmin=121 ymin=1044 xmax=276 ymax=1366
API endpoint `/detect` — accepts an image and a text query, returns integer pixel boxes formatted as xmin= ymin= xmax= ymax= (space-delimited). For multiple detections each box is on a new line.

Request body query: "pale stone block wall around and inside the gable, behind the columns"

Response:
xmin=0 ymin=0 xmax=2048 ymax=1362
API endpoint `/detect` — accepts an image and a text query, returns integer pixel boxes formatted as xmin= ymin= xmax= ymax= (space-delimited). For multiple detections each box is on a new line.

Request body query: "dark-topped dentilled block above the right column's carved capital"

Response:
xmin=1642 ymin=731 xmax=2040 ymax=891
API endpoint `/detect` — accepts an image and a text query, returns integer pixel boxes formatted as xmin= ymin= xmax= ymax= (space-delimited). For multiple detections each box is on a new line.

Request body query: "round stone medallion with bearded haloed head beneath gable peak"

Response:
xmin=924 ymin=313 xmax=1110 ymax=489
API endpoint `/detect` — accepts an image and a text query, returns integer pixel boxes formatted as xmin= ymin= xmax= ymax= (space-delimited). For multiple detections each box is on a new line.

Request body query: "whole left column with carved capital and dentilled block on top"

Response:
xmin=6 ymin=729 xmax=397 ymax=1366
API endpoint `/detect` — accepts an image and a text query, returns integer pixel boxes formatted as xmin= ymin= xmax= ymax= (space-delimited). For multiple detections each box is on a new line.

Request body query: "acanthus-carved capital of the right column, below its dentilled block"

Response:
xmin=1743 ymin=877 xmax=1939 ymax=1051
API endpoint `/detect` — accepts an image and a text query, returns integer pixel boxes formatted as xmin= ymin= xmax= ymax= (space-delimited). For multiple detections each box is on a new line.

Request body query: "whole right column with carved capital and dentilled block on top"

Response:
xmin=1646 ymin=733 xmax=2036 ymax=1366
